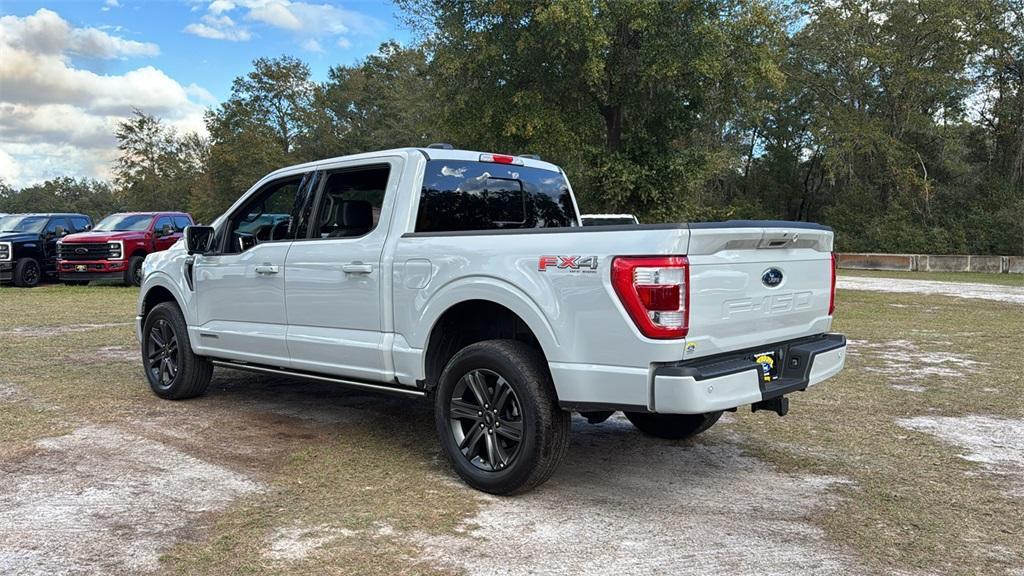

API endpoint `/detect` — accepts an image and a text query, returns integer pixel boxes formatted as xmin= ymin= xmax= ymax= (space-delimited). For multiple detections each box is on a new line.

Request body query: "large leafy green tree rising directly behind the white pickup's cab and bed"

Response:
xmin=400 ymin=0 xmax=784 ymax=220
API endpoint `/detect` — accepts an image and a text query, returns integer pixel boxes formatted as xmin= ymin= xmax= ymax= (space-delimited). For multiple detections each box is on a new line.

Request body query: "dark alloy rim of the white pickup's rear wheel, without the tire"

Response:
xmin=449 ymin=368 xmax=523 ymax=471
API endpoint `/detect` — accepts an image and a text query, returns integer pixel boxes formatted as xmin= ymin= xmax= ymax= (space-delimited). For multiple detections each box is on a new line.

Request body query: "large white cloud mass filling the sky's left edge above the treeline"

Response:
xmin=0 ymin=9 xmax=214 ymax=187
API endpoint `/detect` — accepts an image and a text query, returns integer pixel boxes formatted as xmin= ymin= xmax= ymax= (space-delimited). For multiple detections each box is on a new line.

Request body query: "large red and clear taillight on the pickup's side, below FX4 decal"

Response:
xmin=611 ymin=256 xmax=690 ymax=339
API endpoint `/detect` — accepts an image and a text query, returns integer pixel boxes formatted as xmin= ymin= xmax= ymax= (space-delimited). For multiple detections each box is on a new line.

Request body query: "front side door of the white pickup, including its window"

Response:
xmin=189 ymin=173 xmax=311 ymax=367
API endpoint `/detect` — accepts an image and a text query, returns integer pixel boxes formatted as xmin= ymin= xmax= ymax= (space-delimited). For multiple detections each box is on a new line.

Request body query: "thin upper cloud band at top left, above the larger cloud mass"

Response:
xmin=0 ymin=8 xmax=160 ymax=58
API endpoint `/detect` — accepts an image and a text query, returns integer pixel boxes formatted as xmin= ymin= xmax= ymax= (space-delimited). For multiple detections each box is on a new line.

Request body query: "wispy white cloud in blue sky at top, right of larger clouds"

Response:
xmin=185 ymin=0 xmax=384 ymax=51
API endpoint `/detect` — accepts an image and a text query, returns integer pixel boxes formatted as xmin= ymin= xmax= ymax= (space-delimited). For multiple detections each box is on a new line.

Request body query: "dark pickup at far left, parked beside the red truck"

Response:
xmin=0 ymin=213 xmax=92 ymax=287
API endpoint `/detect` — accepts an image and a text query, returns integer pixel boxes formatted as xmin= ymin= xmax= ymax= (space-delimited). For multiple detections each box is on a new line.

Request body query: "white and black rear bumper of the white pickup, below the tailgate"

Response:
xmin=650 ymin=334 xmax=846 ymax=414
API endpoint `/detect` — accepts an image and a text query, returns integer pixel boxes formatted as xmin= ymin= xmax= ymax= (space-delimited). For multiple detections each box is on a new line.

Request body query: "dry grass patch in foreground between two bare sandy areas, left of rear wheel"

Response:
xmin=163 ymin=417 xmax=479 ymax=575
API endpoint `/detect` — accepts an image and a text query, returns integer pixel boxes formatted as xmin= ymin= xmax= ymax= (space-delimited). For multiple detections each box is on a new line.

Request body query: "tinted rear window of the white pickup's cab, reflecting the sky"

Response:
xmin=416 ymin=160 xmax=575 ymax=232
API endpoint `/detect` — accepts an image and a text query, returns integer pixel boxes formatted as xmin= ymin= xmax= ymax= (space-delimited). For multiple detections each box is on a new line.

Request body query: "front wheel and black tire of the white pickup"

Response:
xmin=141 ymin=302 xmax=213 ymax=400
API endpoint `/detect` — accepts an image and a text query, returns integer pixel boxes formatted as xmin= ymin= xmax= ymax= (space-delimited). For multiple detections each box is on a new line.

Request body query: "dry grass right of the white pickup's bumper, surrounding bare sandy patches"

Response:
xmin=729 ymin=291 xmax=1024 ymax=574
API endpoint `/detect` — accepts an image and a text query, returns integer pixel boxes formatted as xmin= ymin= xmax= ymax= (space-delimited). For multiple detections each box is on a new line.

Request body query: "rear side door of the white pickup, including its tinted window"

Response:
xmin=285 ymin=158 xmax=402 ymax=380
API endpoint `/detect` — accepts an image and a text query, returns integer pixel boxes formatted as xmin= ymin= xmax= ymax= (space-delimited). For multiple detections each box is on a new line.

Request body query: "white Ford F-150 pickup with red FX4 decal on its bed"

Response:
xmin=137 ymin=146 xmax=846 ymax=494
